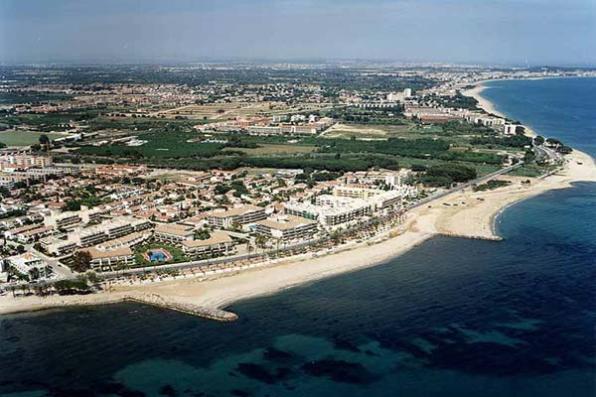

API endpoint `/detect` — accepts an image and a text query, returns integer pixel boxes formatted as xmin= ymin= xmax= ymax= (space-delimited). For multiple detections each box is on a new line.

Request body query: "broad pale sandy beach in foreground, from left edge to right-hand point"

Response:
xmin=0 ymin=147 xmax=596 ymax=314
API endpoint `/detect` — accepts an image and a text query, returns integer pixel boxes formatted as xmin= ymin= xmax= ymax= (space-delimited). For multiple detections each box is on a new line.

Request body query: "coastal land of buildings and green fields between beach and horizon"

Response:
xmin=0 ymin=64 xmax=596 ymax=295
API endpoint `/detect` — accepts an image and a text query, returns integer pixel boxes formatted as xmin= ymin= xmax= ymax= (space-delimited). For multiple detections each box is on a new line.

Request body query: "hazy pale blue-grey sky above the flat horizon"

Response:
xmin=0 ymin=0 xmax=596 ymax=65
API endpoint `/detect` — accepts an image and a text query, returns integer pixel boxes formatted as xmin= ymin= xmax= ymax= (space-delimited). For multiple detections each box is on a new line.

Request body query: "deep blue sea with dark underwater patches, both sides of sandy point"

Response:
xmin=0 ymin=79 xmax=596 ymax=397
